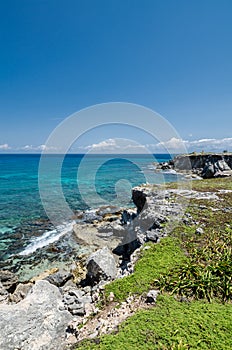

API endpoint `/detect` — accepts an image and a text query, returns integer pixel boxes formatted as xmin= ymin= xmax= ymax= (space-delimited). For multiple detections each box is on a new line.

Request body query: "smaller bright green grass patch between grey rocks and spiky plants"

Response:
xmin=105 ymin=237 xmax=186 ymax=301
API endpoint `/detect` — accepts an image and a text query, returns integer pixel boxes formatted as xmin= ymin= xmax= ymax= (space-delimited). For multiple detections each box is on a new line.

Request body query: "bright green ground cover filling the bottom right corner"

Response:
xmin=78 ymin=295 xmax=232 ymax=350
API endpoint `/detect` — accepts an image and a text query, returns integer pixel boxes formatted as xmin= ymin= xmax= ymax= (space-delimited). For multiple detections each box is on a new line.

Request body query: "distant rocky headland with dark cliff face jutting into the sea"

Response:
xmin=156 ymin=152 xmax=232 ymax=179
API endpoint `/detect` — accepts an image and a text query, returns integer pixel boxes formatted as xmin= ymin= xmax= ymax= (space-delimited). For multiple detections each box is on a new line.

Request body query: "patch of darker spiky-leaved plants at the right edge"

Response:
xmin=157 ymin=215 xmax=232 ymax=302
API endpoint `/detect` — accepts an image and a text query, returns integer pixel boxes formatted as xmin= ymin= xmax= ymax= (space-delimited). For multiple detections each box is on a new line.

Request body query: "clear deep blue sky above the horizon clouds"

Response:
xmin=0 ymin=0 xmax=232 ymax=152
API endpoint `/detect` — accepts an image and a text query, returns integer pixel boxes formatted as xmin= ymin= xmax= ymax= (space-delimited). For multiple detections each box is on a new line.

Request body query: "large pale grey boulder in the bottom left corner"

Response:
xmin=0 ymin=280 xmax=72 ymax=350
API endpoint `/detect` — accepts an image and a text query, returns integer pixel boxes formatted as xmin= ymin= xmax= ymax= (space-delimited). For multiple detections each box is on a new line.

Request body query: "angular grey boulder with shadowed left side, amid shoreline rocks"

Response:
xmin=87 ymin=247 xmax=117 ymax=282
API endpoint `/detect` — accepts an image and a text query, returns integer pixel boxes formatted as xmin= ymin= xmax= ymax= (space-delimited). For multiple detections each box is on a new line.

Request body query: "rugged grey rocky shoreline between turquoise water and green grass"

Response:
xmin=0 ymin=174 xmax=225 ymax=350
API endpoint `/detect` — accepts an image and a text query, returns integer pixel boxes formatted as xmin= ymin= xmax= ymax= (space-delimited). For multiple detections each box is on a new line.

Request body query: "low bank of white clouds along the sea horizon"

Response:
xmin=0 ymin=137 xmax=232 ymax=154
